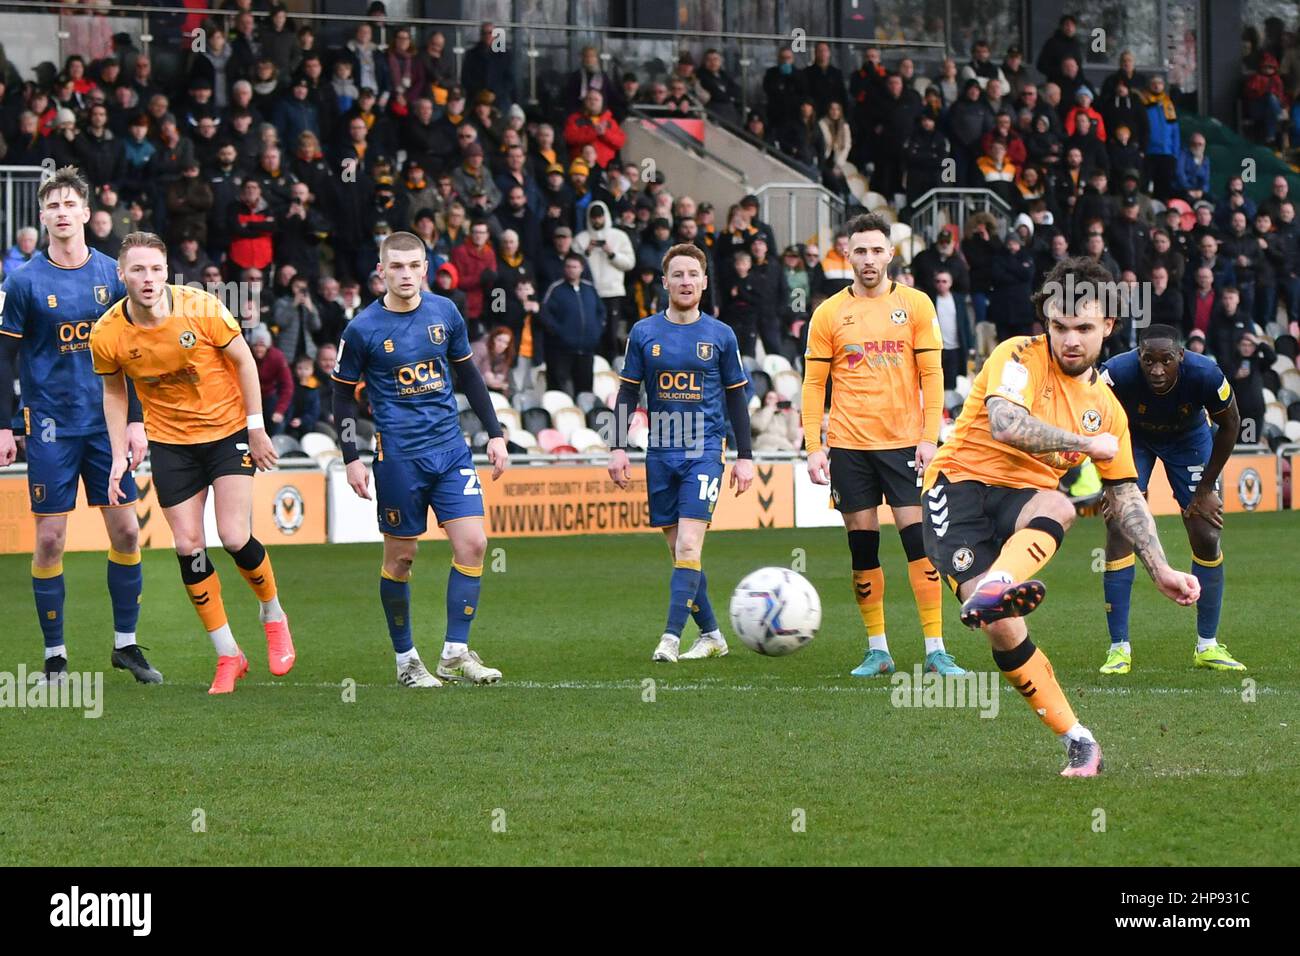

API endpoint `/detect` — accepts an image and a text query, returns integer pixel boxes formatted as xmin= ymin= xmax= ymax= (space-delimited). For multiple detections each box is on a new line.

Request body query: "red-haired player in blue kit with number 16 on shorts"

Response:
xmin=610 ymin=243 xmax=754 ymax=663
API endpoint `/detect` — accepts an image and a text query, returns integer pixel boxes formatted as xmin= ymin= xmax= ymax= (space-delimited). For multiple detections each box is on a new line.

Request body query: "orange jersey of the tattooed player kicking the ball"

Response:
xmin=923 ymin=336 xmax=1138 ymax=490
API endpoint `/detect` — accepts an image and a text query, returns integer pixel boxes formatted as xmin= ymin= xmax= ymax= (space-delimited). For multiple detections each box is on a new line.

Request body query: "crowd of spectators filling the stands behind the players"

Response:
xmin=0 ymin=0 xmax=1300 ymax=447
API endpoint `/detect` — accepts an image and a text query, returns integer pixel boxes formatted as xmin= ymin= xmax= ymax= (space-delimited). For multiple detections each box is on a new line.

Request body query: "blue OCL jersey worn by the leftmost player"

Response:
xmin=0 ymin=250 xmax=126 ymax=436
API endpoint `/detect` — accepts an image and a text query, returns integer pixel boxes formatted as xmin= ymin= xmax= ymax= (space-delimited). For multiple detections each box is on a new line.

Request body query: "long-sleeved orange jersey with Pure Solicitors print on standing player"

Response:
xmin=803 ymin=282 xmax=944 ymax=453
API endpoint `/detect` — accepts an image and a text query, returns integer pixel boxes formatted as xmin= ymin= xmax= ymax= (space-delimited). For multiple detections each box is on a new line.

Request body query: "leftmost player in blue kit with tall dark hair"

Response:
xmin=0 ymin=166 xmax=163 ymax=684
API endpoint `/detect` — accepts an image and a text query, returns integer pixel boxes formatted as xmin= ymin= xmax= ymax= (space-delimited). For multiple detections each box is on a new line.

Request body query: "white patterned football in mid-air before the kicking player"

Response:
xmin=731 ymin=567 xmax=822 ymax=657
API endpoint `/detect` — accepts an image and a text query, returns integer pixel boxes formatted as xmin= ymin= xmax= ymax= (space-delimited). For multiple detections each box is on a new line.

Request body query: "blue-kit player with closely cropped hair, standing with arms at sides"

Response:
xmin=333 ymin=233 xmax=510 ymax=687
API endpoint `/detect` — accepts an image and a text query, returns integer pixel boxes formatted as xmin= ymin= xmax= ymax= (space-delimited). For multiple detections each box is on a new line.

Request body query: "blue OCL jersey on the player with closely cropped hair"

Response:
xmin=334 ymin=293 xmax=472 ymax=457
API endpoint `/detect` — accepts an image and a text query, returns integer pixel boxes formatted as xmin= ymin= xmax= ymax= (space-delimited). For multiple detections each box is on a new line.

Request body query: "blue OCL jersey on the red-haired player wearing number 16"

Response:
xmin=620 ymin=312 xmax=749 ymax=453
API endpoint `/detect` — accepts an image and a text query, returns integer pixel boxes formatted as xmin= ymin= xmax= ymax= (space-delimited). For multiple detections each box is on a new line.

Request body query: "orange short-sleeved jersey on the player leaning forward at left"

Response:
xmin=90 ymin=285 xmax=247 ymax=445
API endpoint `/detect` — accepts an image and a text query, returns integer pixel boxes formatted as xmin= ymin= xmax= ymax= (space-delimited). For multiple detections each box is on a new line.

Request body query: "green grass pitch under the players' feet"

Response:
xmin=0 ymin=512 xmax=1300 ymax=866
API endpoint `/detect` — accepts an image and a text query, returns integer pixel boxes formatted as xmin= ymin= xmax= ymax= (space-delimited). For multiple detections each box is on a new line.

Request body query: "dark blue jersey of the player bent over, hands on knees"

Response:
xmin=1101 ymin=349 xmax=1232 ymax=440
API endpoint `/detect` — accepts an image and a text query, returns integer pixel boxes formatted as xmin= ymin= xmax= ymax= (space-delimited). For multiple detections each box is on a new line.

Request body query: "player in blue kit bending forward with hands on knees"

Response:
xmin=1101 ymin=325 xmax=1245 ymax=674
